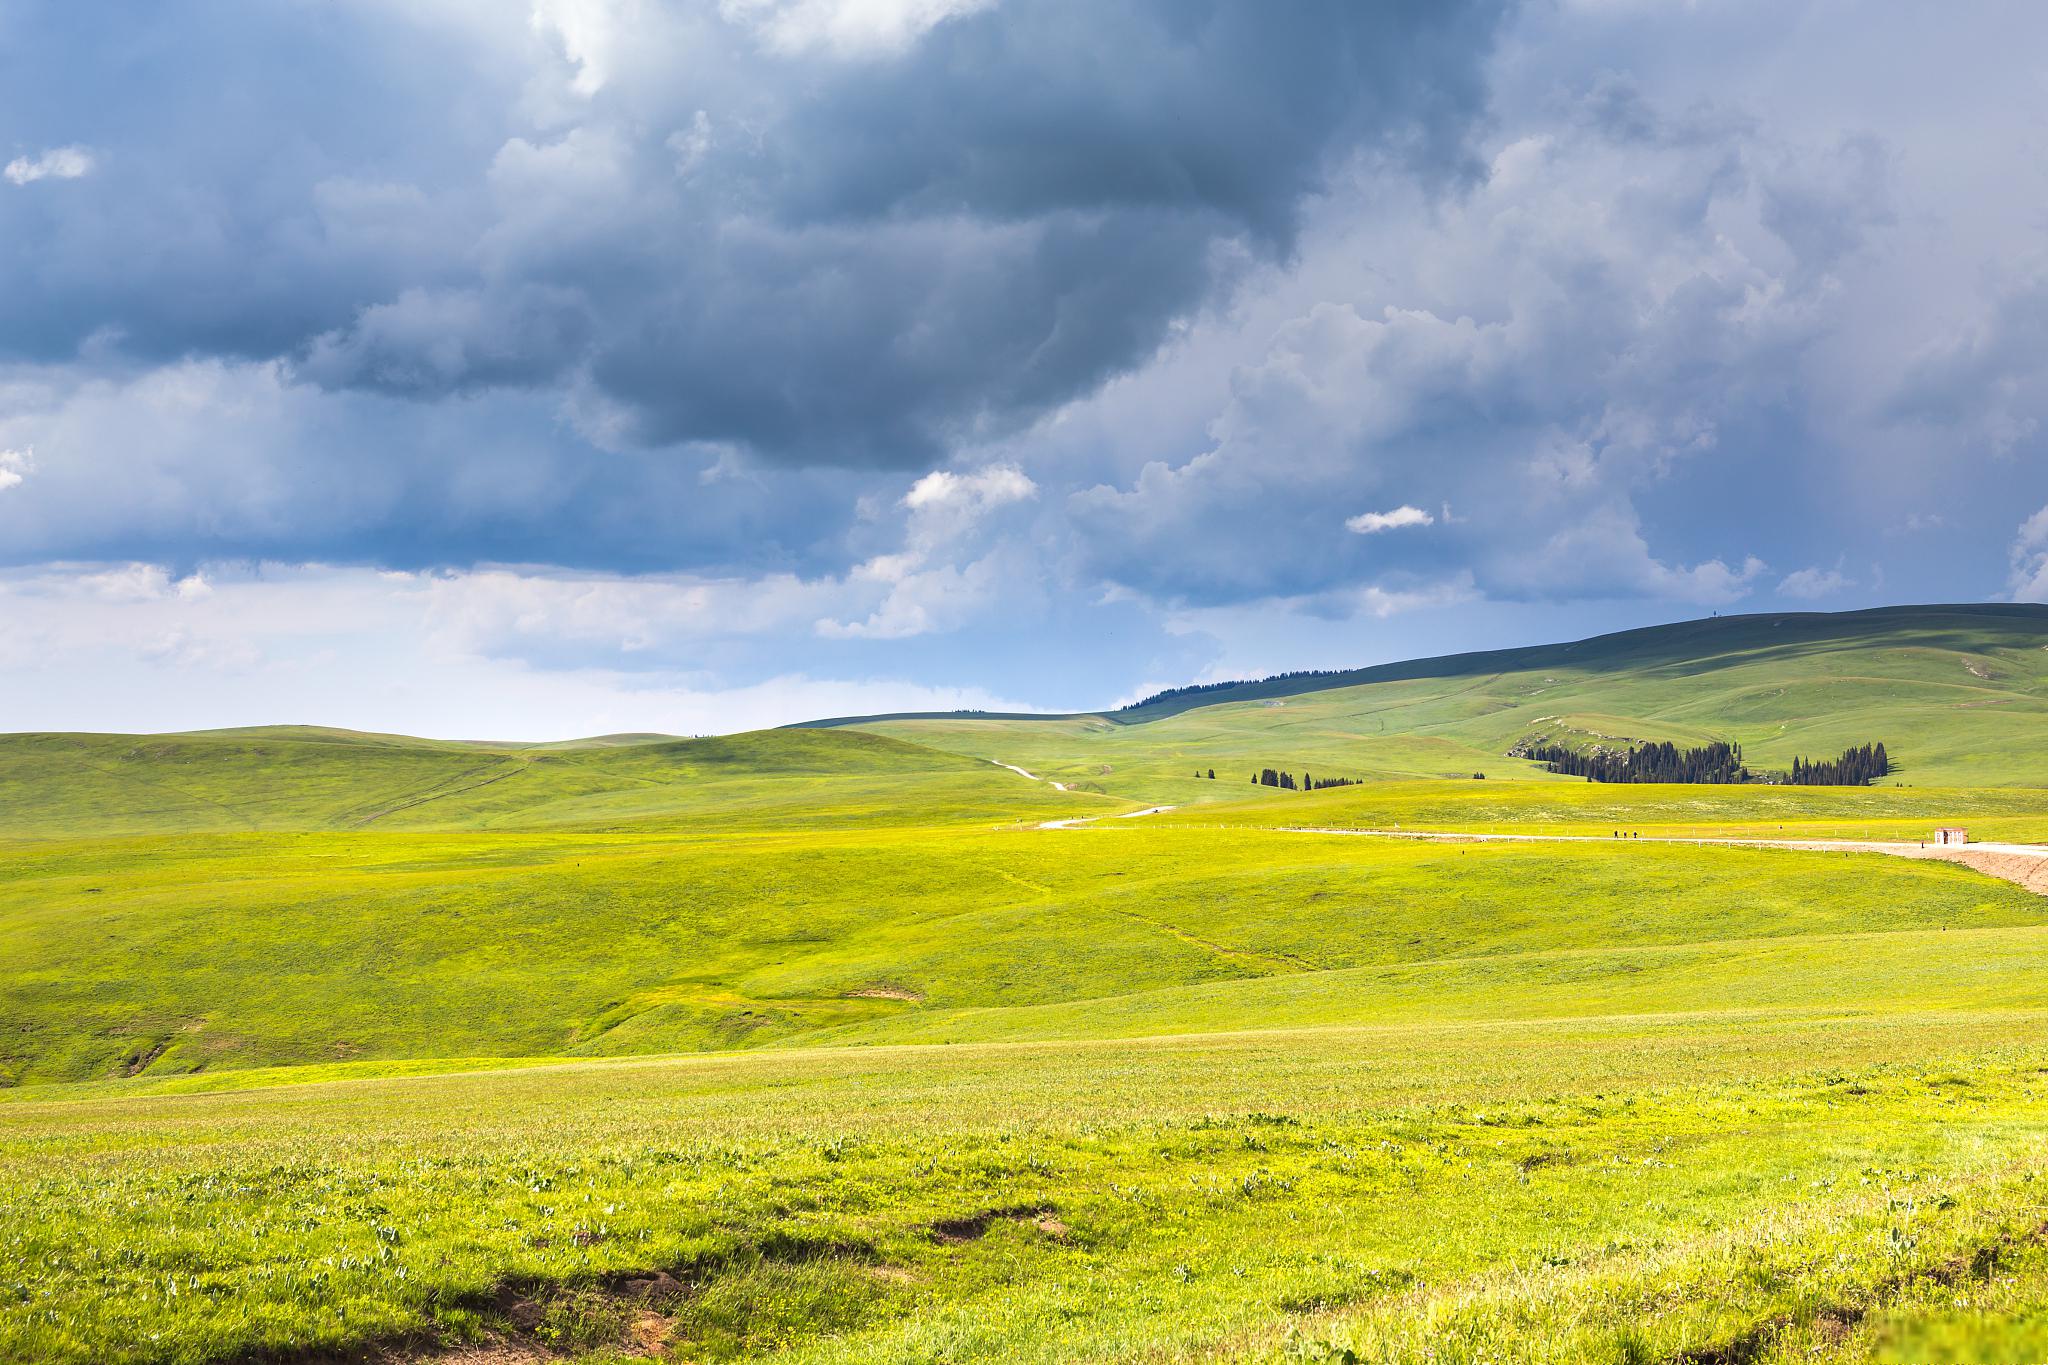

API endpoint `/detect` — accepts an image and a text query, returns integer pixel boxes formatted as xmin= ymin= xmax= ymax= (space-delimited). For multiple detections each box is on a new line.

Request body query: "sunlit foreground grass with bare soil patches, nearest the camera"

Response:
xmin=12 ymin=1011 xmax=2048 ymax=1361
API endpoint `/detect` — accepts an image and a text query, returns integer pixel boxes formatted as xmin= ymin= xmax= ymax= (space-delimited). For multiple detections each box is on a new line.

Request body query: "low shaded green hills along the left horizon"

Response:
xmin=0 ymin=726 xmax=1114 ymax=837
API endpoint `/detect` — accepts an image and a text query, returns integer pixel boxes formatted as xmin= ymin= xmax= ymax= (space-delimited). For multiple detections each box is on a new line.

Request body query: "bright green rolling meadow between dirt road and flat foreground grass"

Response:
xmin=0 ymin=821 xmax=2048 ymax=1083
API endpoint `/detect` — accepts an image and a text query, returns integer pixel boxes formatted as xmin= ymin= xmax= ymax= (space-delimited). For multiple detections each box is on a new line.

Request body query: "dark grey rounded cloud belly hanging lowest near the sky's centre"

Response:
xmin=592 ymin=204 xmax=1212 ymax=467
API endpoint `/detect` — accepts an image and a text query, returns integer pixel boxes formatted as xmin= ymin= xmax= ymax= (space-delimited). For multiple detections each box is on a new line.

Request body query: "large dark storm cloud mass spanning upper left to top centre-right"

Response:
xmin=0 ymin=0 xmax=1503 ymax=467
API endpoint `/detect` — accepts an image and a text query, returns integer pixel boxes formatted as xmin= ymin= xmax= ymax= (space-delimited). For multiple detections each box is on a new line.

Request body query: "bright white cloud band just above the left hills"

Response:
xmin=0 ymin=563 xmax=1030 ymax=739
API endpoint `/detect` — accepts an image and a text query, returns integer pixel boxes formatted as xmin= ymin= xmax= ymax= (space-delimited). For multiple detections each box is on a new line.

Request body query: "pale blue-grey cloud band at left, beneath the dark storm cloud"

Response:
xmin=0 ymin=360 xmax=868 ymax=575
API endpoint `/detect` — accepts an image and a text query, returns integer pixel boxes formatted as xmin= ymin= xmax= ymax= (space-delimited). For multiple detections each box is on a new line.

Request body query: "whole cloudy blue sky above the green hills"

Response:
xmin=0 ymin=0 xmax=2048 ymax=739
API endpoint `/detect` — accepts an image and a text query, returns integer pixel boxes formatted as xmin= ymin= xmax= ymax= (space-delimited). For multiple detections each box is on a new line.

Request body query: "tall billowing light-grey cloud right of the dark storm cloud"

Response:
xmin=1069 ymin=78 xmax=1886 ymax=604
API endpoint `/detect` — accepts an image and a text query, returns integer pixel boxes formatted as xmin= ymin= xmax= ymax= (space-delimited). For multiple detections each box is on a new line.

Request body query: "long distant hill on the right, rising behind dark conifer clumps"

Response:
xmin=858 ymin=604 xmax=2048 ymax=804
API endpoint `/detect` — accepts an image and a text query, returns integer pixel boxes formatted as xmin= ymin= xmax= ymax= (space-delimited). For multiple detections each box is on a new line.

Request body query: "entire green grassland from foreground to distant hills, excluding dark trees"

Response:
xmin=12 ymin=608 xmax=2048 ymax=1365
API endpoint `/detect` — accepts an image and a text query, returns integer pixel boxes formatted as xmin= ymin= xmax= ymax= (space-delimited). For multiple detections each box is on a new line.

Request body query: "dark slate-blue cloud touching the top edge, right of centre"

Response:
xmin=761 ymin=0 xmax=1501 ymax=241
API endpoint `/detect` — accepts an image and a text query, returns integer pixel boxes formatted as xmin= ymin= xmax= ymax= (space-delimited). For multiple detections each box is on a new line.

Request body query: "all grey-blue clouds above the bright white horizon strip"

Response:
xmin=0 ymin=0 xmax=2048 ymax=657
